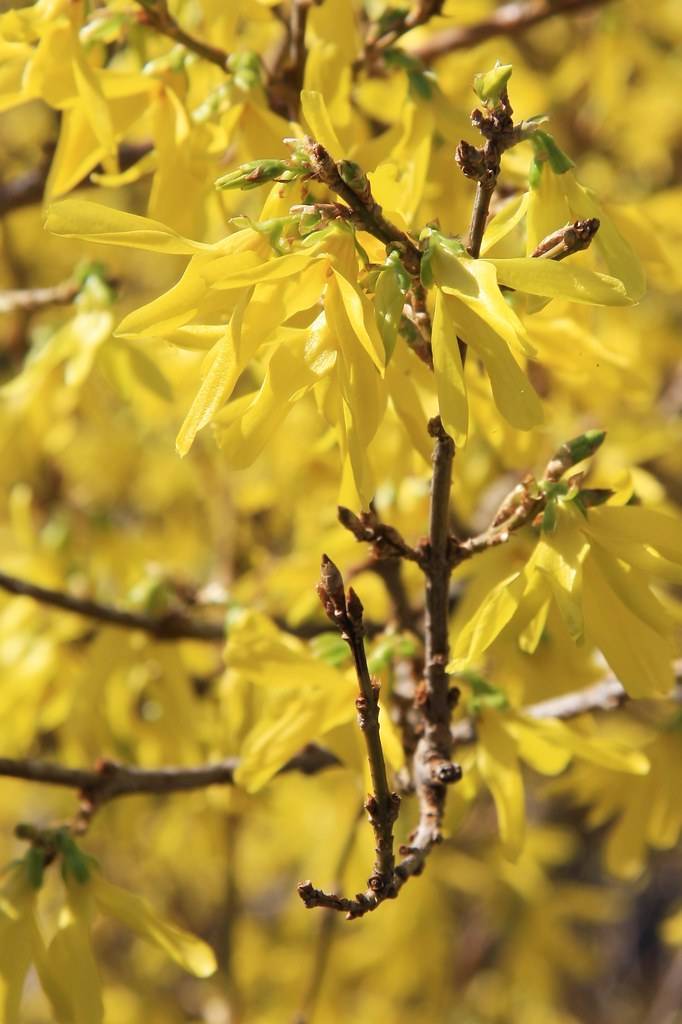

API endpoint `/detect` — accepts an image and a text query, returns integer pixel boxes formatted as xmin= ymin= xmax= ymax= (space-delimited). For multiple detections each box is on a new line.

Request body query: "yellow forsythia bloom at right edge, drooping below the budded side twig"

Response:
xmin=451 ymin=500 xmax=682 ymax=697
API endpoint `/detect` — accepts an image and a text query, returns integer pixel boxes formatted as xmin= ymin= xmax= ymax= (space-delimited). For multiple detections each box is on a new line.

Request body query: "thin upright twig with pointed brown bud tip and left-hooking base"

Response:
xmin=298 ymin=555 xmax=400 ymax=918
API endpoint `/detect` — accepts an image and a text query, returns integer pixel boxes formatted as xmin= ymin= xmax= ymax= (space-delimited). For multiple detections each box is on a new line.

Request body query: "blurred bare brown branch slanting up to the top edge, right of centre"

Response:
xmin=407 ymin=0 xmax=607 ymax=63
